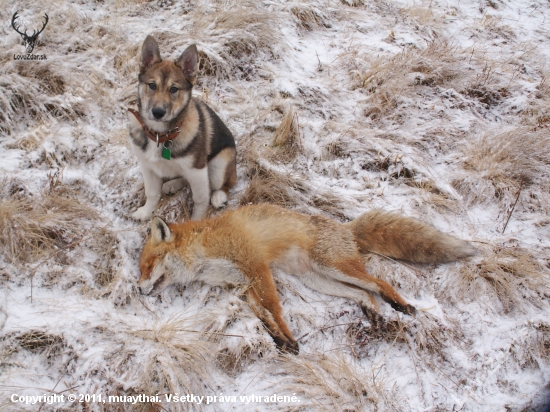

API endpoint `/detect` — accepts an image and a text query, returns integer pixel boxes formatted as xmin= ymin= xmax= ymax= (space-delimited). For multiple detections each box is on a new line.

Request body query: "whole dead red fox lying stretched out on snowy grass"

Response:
xmin=138 ymin=204 xmax=477 ymax=353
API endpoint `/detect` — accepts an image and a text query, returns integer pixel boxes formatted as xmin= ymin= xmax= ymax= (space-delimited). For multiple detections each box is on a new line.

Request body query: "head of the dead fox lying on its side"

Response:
xmin=138 ymin=217 xmax=181 ymax=296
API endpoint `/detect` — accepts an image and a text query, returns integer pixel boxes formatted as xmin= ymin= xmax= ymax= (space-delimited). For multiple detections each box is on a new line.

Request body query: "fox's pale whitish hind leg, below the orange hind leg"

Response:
xmin=300 ymin=267 xmax=384 ymax=328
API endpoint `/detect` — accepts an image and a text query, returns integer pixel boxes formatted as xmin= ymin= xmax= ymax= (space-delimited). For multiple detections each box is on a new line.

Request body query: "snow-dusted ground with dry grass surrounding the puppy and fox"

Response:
xmin=0 ymin=0 xmax=550 ymax=411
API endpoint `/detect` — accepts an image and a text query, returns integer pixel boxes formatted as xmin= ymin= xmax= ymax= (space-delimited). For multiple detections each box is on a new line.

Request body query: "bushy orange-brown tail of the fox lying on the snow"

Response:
xmin=345 ymin=210 xmax=477 ymax=263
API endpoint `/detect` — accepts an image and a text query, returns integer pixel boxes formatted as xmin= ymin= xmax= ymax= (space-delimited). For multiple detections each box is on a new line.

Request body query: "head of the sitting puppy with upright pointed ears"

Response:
xmin=138 ymin=36 xmax=199 ymax=128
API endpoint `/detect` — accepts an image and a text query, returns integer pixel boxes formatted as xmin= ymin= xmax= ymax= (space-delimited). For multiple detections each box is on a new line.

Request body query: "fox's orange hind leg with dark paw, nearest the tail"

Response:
xmin=334 ymin=259 xmax=416 ymax=315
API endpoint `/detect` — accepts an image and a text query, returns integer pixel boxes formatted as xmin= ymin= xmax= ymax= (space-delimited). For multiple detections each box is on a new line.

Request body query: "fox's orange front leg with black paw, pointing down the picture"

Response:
xmin=245 ymin=266 xmax=298 ymax=353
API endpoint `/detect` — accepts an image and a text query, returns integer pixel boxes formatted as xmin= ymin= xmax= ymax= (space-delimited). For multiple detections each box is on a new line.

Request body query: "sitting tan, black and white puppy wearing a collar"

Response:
xmin=128 ymin=36 xmax=237 ymax=220
